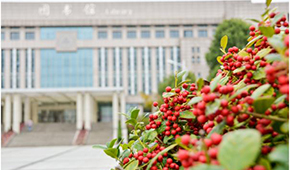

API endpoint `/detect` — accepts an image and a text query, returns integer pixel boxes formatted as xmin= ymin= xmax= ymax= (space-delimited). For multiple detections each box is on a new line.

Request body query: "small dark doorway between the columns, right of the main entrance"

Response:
xmin=98 ymin=103 xmax=113 ymax=122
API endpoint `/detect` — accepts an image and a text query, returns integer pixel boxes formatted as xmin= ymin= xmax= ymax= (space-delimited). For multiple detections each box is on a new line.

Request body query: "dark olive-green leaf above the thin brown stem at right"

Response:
xmin=253 ymin=96 xmax=275 ymax=114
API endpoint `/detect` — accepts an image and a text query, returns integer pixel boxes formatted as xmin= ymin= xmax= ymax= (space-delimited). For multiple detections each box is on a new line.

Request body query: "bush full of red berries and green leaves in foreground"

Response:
xmin=94 ymin=1 xmax=289 ymax=170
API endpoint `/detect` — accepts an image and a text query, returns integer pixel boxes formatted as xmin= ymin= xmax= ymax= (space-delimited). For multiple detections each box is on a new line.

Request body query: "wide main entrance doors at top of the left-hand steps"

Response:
xmin=38 ymin=110 xmax=76 ymax=123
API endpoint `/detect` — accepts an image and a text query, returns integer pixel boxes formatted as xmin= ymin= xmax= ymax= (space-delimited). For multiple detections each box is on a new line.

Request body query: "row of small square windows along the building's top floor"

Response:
xmin=1 ymin=30 xmax=212 ymax=40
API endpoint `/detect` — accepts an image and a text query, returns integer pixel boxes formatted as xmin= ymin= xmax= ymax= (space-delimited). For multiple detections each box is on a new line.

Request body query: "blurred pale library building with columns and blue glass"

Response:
xmin=1 ymin=1 xmax=288 ymax=146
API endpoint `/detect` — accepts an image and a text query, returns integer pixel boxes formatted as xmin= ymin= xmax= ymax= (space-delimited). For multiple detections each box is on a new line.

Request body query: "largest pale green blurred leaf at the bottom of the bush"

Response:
xmin=218 ymin=129 xmax=261 ymax=170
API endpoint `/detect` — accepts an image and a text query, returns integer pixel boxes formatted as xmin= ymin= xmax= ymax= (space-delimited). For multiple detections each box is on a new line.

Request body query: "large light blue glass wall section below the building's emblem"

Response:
xmin=40 ymin=49 xmax=93 ymax=88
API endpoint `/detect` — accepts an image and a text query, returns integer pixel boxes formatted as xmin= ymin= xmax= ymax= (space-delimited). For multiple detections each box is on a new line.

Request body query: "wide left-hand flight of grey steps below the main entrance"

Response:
xmin=7 ymin=123 xmax=76 ymax=147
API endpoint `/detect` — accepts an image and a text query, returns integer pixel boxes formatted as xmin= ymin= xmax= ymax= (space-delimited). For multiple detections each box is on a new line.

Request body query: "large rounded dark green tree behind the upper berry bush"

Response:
xmin=205 ymin=19 xmax=249 ymax=81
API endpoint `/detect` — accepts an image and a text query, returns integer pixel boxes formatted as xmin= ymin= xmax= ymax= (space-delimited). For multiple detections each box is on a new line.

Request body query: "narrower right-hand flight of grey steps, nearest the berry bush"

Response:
xmin=86 ymin=122 xmax=113 ymax=145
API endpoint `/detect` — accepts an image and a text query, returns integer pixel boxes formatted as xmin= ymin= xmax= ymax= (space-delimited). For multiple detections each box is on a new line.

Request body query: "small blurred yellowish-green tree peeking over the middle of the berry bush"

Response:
xmin=158 ymin=72 xmax=196 ymax=96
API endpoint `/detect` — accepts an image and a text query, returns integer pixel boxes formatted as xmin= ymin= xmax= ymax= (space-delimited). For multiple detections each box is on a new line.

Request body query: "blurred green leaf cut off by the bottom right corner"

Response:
xmin=269 ymin=145 xmax=289 ymax=169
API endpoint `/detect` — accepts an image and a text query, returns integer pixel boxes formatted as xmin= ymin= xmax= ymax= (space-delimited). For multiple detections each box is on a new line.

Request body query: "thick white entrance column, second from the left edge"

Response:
xmin=12 ymin=94 xmax=22 ymax=133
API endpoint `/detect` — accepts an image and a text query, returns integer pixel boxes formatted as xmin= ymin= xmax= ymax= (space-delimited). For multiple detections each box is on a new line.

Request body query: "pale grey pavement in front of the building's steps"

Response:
xmin=1 ymin=145 xmax=117 ymax=170
